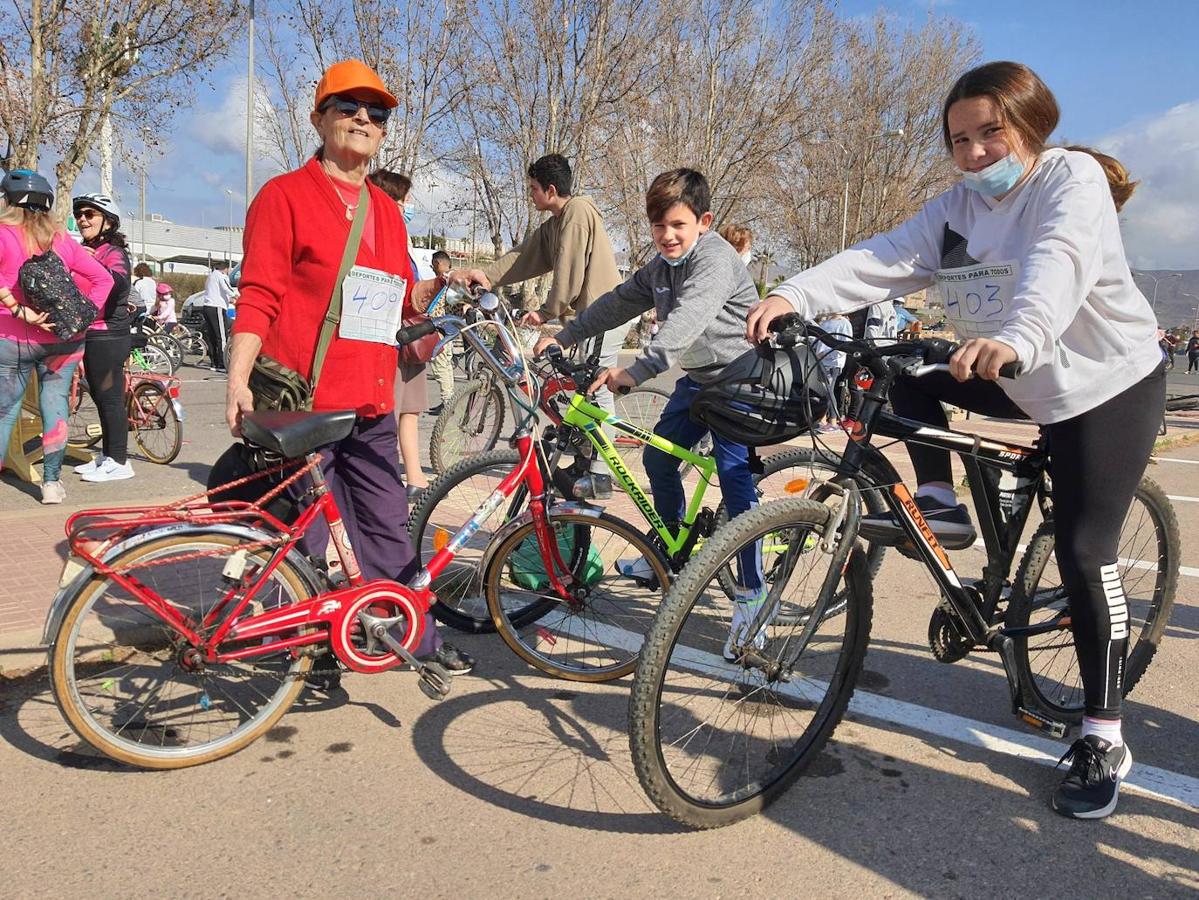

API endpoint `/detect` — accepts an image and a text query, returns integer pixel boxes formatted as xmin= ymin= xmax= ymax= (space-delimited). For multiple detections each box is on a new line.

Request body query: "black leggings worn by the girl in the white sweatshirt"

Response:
xmin=891 ymin=363 xmax=1165 ymax=719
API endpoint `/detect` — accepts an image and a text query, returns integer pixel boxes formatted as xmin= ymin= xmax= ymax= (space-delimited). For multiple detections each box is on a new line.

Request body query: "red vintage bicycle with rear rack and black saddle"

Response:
xmin=44 ymin=300 xmax=669 ymax=768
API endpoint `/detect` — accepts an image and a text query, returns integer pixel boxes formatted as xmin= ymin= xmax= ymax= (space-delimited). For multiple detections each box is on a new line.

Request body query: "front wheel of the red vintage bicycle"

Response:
xmin=483 ymin=509 xmax=670 ymax=682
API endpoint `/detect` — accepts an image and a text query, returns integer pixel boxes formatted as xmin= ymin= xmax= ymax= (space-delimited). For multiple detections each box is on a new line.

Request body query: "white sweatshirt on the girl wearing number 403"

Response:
xmin=772 ymin=149 xmax=1161 ymax=424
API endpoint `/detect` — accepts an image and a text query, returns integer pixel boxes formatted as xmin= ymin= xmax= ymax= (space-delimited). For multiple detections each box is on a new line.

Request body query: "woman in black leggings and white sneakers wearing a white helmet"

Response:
xmin=71 ymin=194 xmax=133 ymax=482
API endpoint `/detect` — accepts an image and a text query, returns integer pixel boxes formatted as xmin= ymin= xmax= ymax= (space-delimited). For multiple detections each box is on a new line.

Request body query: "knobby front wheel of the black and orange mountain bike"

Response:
xmin=628 ymin=499 xmax=872 ymax=828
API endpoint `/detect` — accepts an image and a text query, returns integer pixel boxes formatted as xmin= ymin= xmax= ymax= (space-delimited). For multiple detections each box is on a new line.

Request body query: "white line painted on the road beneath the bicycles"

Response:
xmin=549 ymin=617 xmax=1199 ymax=809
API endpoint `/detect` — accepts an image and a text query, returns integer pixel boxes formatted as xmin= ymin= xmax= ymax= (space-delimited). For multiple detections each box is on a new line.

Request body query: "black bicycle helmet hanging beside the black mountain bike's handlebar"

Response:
xmin=691 ymin=344 xmax=829 ymax=447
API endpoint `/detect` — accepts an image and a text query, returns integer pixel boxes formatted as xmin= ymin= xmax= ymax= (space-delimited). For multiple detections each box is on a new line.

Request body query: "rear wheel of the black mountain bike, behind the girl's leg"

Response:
xmin=1005 ymin=476 xmax=1182 ymax=724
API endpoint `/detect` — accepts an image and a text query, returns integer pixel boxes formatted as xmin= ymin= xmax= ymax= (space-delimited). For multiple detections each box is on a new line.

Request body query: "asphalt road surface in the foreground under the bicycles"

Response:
xmin=0 ymin=357 xmax=1199 ymax=898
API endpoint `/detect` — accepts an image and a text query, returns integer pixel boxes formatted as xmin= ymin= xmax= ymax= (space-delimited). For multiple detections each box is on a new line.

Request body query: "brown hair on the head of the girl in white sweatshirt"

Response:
xmin=941 ymin=61 xmax=1061 ymax=153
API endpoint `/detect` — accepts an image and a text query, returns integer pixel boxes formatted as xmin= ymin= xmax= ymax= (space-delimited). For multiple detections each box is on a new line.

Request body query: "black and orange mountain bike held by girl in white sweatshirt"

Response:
xmin=629 ymin=321 xmax=1181 ymax=828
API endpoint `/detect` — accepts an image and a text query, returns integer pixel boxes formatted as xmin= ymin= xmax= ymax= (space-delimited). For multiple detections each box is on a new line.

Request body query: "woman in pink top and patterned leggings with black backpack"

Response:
xmin=0 ymin=169 xmax=113 ymax=503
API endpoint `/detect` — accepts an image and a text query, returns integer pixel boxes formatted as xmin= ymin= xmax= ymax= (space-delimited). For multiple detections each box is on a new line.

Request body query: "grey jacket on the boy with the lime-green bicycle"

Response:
xmin=558 ymin=231 xmax=758 ymax=385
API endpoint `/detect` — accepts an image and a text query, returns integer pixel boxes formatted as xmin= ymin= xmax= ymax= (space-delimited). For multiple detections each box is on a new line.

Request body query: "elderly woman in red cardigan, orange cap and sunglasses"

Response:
xmin=225 ymin=60 xmax=474 ymax=687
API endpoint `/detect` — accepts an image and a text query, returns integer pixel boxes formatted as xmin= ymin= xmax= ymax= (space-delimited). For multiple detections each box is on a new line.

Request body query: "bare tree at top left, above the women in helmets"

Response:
xmin=0 ymin=0 xmax=241 ymax=212
